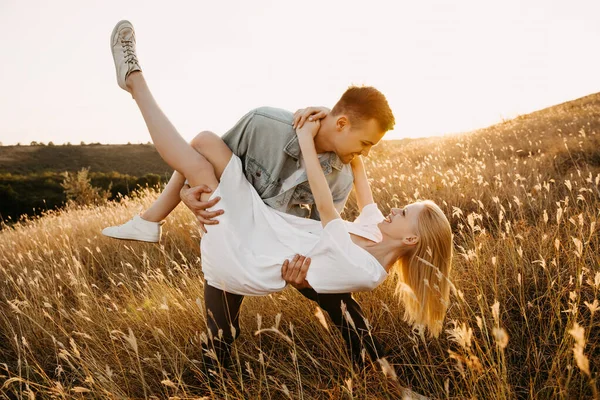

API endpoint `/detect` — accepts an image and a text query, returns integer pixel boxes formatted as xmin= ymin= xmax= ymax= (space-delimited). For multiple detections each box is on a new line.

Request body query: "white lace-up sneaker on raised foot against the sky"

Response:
xmin=110 ymin=20 xmax=142 ymax=92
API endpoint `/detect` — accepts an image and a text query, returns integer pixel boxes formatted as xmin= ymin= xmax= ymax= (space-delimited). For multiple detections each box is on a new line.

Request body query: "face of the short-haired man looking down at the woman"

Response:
xmin=335 ymin=116 xmax=385 ymax=164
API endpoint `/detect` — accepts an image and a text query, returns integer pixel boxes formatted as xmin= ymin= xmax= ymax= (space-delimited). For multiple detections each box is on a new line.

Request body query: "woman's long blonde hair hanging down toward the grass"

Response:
xmin=395 ymin=200 xmax=452 ymax=337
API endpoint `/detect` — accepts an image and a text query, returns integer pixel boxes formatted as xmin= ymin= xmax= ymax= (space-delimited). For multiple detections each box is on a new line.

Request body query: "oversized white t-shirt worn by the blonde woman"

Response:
xmin=200 ymin=155 xmax=388 ymax=296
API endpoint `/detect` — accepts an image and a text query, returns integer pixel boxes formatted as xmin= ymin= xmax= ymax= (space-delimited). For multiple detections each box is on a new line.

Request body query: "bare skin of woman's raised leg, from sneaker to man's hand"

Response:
xmin=127 ymin=71 xmax=219 ymax=201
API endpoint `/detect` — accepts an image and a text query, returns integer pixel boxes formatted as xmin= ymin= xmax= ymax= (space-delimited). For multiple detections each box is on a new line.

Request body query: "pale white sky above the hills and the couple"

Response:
xmin=0 ymin=0 xmax=600 ymax=145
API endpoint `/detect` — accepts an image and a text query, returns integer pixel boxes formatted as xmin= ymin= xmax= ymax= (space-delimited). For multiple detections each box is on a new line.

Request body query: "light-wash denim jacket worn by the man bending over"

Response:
xmin=223 ymin=107 xmax=354 ymax=220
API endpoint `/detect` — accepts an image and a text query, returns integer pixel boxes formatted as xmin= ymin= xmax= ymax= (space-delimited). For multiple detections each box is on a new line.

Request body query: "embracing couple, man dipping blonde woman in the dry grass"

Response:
xmin=103 ymin=21 xmax=452 ymax=370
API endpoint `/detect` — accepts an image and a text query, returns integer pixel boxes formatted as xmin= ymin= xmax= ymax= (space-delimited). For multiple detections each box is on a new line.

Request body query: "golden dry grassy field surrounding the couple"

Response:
xmin=0 ymin=95 xmax=600 ymax=399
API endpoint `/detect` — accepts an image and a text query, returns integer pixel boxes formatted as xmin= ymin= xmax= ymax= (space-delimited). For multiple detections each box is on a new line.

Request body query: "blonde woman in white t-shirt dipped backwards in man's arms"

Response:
xmin=109 ymin=19 xmax=452 ymax=336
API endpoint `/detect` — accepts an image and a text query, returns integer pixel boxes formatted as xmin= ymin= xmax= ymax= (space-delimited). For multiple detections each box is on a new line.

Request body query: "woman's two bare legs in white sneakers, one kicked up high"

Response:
xmin=102 ymin=21 xmax=231 ymax=242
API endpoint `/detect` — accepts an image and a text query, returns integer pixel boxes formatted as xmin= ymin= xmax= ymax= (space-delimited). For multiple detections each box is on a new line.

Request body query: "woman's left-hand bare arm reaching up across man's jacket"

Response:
xmin=296 ymin=121 xmax=340 ymax=227
